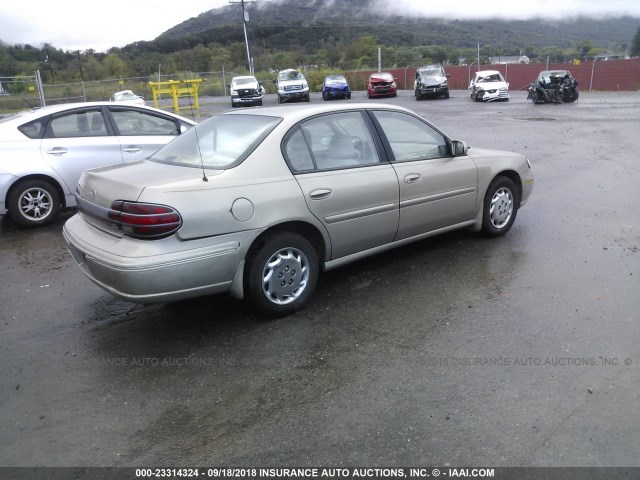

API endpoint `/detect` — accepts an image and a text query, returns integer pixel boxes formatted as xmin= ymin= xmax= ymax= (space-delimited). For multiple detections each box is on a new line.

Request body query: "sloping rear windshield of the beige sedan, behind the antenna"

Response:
xmin=149 ymin=115 xmax=282 ymax=170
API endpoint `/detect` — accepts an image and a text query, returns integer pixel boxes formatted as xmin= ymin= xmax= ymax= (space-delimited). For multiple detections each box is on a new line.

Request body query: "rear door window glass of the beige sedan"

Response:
xmin=284 ymin=112 xmax=380 ymax=170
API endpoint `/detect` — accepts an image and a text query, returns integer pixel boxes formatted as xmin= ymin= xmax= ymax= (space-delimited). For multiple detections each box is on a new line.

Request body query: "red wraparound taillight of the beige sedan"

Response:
xmin=108 ymin=200 xmax=182 ymax=239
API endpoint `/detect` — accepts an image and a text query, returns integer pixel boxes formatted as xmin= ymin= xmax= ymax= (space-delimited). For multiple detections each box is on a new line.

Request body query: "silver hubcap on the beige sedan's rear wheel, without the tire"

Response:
xmin=262 ymin=247 xmax=309 ymax=305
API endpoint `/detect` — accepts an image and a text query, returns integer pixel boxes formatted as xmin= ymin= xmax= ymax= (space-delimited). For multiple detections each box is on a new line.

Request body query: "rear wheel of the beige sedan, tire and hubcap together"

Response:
xmin=244 ymin=232 xmax=320 ymax=317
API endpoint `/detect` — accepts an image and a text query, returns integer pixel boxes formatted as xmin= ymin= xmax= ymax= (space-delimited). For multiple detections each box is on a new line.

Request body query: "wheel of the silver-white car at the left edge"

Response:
xmin=8 ymin=180 xmax=60 ymax=227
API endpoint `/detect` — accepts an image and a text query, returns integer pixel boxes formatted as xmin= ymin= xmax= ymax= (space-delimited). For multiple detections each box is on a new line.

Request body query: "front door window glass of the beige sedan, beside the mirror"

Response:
xmin=374 ymin=110 xmax=448 ymax=162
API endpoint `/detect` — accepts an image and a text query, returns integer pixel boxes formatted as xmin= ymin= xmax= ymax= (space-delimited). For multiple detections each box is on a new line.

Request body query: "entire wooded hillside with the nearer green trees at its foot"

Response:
xmin=0 ymin=0 xmax=640 ymax=83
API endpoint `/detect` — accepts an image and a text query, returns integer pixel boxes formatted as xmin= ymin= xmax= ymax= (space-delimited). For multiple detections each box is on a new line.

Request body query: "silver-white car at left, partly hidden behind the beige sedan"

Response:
xmin=0 ymin=102 xmax=195 ymax=227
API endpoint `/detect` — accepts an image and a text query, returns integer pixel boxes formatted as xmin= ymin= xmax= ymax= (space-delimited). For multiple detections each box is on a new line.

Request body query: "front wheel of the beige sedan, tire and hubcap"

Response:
xmin=482 ymin=177 xmax=520 ymax=237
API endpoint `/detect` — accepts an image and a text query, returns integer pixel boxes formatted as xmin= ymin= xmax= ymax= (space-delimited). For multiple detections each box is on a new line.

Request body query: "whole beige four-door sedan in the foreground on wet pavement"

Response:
xmin=64 ymin=104 xmax=533 ymax=316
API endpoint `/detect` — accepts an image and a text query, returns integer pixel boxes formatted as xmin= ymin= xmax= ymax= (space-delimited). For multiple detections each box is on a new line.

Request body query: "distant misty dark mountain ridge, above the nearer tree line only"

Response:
xmin=142 ymin=0 xmax=640 ymax=53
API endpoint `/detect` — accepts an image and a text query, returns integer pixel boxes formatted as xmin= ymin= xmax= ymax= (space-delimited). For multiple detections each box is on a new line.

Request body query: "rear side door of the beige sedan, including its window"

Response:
xmin=283 ymin=111 xmax=399 ymax=259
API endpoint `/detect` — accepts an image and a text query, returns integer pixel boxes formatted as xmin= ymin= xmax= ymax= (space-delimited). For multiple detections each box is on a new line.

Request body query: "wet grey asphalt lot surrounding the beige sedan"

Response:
xmin=0 ymin=91 xmax=640 ymax=467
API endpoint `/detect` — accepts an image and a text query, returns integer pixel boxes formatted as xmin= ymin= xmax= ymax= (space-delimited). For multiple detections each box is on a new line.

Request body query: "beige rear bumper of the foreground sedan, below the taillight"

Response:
xmin=63 ymin=214 xmax=260 ymax=303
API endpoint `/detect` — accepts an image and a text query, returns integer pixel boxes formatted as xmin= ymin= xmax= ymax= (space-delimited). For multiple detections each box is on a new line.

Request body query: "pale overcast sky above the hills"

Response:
xmin=0 ymin=0 xmax=640 ymax=52
